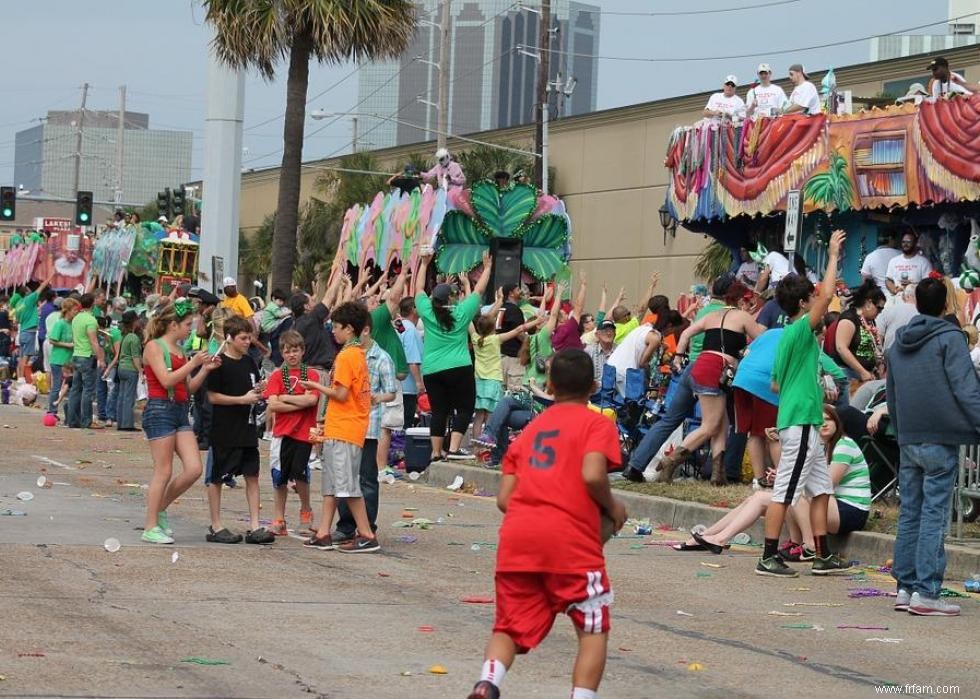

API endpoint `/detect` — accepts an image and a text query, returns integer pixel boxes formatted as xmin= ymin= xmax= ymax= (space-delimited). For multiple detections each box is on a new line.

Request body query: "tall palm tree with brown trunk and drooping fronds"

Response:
xmin=204 ymin=0 xmax=416 ymax=287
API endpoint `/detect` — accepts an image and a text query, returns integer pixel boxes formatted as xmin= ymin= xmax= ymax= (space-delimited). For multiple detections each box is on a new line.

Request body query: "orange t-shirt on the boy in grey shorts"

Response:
xmin=323 ymin=345 xmax=371 ymax=447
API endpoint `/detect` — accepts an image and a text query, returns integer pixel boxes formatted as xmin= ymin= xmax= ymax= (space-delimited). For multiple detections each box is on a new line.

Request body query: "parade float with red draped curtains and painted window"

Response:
xmin=665 ymin=96 xmax=980 ymax=284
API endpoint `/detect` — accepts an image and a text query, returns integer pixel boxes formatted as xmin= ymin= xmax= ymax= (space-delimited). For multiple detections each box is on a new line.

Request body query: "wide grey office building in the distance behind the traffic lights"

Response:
xmin=14 ymin=110 xmax=193 ymax=204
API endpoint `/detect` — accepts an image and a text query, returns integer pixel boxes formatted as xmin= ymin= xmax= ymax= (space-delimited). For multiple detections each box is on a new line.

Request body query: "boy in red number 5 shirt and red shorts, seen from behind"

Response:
xmin=469 ymin=349 xmax=626 ymax=699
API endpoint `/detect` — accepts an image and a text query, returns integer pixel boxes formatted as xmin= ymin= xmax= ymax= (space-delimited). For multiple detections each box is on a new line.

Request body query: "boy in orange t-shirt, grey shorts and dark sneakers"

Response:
xmin=299 ymin=302 xmax=381 ymax=553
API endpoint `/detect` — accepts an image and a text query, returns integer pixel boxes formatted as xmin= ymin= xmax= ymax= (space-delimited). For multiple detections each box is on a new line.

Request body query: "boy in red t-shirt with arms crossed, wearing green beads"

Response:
xmin=264 ymin=330 xmax=320 ymax=536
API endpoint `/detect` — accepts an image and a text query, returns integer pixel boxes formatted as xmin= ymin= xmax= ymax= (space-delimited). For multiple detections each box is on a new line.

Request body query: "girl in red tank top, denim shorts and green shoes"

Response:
xmin=142 ymin=301 xmax=221 ymax=544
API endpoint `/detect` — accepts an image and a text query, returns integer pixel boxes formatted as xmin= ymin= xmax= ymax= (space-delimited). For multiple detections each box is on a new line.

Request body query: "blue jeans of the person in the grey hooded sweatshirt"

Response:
xmin=892 ymin=444 xmax=959 ymax=599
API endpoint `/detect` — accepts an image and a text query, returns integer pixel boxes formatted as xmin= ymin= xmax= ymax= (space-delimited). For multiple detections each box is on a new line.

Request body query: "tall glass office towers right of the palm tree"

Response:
xmin=356 ymin=0 xmax=600 ymax=148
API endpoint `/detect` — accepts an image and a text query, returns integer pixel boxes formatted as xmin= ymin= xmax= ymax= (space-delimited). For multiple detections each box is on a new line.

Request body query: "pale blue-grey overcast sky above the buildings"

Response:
xmin=0 ymin=0 xmax=947 ymax=190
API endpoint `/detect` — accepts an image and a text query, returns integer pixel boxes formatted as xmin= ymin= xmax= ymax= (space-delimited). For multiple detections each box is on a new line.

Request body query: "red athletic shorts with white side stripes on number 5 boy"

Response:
xmin=493 ymin=569 xmax=613 ymax=653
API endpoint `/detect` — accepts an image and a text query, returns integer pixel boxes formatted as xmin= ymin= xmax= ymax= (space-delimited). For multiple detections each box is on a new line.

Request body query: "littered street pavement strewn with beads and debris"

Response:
xmin=0 ymin=405 xmax=980 ymax=699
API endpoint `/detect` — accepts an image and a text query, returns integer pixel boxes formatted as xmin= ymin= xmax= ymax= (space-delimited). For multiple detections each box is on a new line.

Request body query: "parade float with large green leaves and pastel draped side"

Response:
xmin=335 ymin=180 xmax=571 ymax=282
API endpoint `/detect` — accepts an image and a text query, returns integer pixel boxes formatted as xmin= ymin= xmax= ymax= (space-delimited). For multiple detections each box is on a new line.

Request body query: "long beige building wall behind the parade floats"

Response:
xmin=228 ymin=47 xmax=980 ymax=308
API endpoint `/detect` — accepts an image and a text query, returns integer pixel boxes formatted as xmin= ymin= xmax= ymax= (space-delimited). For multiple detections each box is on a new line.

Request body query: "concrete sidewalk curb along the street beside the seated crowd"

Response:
xmin=418 ymin=461 xmax=980 ymax=591
